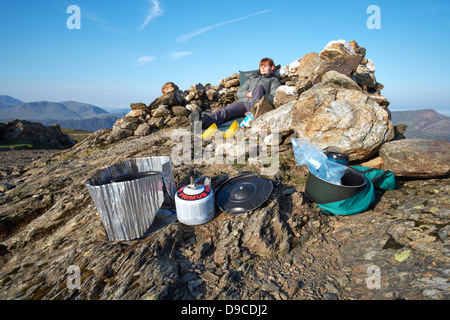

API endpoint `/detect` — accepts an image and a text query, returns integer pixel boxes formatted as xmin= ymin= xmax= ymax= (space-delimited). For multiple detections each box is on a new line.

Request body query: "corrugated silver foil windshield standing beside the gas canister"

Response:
xmin=85 ymin=157 xmax=176 ymax=241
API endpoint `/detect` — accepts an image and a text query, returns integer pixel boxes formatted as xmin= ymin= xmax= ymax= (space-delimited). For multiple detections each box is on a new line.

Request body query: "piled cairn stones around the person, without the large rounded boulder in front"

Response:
xmin=108 ymin=40 xmax=389 ymax=142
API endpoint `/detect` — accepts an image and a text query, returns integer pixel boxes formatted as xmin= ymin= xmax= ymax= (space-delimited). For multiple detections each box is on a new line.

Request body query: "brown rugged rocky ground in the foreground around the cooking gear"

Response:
xmin=0 ymin=130 xmax=450 ymax=300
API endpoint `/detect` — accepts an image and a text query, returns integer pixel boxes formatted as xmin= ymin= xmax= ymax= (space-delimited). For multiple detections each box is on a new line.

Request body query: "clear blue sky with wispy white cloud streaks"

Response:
xmin=0 ymin=0 xmax=450 ymax=115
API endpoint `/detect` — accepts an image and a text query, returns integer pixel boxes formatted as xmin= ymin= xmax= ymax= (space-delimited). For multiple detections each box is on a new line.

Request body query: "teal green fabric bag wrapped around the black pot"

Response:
xmin=316 ymin=166 xmax=398 ymax=216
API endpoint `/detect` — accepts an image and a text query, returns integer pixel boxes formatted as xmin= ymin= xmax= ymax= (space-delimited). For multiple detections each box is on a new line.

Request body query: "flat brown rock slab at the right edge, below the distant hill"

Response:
xmin=380 ymin=139 xmax=450 ymax=178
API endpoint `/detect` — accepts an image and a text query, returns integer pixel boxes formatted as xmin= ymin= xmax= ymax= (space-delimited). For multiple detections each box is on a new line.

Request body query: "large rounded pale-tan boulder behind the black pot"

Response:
xmin=292 ymin=83 xmax=394 ymax=160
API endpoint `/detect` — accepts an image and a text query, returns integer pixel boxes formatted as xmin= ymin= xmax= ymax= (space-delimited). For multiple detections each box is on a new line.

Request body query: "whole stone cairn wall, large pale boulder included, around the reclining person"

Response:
xmin=107 ymin=40 xmax=446 ymax=171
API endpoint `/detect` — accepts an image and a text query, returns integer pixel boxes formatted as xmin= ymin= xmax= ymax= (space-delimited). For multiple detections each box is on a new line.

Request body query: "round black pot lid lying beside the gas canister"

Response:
xmin=215 ymin=172 xmax=273 ymax=215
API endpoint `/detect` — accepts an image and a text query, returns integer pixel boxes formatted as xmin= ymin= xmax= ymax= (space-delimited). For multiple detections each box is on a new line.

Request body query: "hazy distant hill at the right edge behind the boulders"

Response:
xmin=391 ymin=109 xmax=450 ymax=142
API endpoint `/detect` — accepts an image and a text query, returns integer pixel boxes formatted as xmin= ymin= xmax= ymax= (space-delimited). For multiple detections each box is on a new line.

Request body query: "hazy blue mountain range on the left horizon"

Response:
xmin=0 ymin=95 xmax=129 ymax=132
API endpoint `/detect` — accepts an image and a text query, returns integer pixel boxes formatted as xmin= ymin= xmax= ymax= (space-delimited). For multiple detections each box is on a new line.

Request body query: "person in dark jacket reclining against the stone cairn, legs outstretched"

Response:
xmin=189 ymin=58 xmax=281 ymax=132
